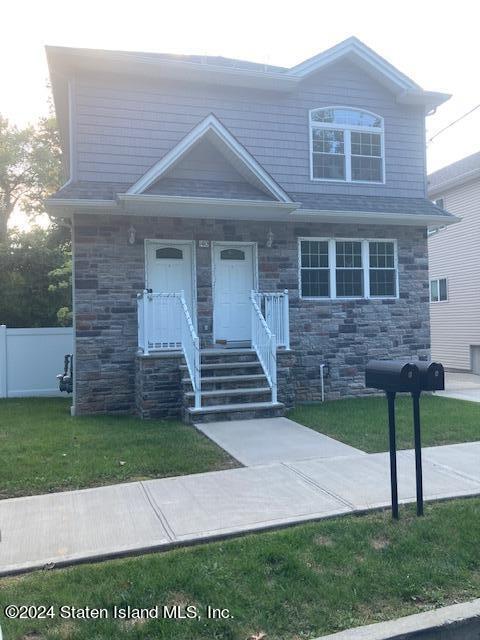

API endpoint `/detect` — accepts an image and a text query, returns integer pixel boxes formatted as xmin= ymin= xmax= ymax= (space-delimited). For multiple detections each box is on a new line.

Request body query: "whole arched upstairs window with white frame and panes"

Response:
xmin=310 ymin=107 xmax=385 ymax=182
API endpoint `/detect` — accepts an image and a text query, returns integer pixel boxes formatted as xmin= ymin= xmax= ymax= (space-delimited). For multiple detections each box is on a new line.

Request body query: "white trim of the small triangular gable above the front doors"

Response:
xmin=127 ymin=114 xmax=292 ymax=202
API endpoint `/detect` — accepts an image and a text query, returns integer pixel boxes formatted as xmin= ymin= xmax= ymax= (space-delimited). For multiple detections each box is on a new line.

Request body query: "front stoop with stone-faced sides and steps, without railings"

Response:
xmin=135 ymin=348 xmax=295 ymax=424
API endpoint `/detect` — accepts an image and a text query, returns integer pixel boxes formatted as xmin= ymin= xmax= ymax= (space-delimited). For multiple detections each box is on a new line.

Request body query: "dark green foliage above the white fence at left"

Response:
xmin=0 ymin=227 xmax=72 ymax=327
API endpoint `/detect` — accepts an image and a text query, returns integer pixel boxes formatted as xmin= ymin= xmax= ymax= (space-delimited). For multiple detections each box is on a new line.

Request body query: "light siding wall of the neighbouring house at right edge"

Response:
xmin=428 ymin=180 xmax=480 ymax=370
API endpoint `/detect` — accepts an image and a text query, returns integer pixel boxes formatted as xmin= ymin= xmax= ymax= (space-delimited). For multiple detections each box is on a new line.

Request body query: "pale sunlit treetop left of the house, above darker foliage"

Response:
xmin=0 ymin=115 xmax=63 ymax=241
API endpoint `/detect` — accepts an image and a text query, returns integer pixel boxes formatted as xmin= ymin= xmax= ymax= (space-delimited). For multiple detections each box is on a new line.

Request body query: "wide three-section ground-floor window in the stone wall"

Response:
xmin=299 ymin=238 xmax=398 ymax=299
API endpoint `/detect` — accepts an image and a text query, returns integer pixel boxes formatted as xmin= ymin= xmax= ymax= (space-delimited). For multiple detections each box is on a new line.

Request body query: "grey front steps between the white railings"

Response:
xmin=181 ymin=348 xmax=285 ymax=423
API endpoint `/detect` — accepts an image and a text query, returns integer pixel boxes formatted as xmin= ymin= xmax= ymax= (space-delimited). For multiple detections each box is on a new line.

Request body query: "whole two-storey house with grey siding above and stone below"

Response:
xmin=47 ymin=38 xmax=454 ymax=420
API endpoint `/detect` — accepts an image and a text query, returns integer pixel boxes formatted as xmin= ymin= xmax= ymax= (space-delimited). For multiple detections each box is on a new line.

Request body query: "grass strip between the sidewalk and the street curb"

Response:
xmin=0 ymin=498 xmax=480 ymax=640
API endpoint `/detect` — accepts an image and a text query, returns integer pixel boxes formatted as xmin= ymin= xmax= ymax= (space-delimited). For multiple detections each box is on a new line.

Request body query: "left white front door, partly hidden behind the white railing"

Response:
xmin=146 ymin=240 xmax=195 ymax=347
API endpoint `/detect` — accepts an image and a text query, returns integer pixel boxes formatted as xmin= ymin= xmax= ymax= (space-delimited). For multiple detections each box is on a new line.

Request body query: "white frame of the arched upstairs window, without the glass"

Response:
xmin=308 ymin=105 xmax=385 ymax=184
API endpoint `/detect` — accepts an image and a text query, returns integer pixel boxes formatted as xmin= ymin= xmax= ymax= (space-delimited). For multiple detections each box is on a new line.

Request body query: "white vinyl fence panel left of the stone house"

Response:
xmin=0 ymin=325 xmax=73 ymax=398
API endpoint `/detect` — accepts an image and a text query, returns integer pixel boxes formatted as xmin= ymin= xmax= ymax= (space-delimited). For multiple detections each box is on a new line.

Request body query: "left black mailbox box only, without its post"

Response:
xmin=365 ymin=360 xmax=420 ymax=391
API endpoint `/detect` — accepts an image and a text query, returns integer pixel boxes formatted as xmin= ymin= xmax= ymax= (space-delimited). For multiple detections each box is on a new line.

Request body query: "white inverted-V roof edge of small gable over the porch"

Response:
xmin=127 ymin=113 xmax=292 ymax=202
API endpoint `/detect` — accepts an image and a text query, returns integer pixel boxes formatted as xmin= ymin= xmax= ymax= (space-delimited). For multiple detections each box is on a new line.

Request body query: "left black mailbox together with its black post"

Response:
xmin=365 ymin=360 xmax=420 ymax=520
